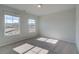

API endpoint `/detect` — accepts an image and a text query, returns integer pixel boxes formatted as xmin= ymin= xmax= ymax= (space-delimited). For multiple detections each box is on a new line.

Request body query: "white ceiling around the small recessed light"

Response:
xmin=7 ymin=4 xmax=75 ymax=16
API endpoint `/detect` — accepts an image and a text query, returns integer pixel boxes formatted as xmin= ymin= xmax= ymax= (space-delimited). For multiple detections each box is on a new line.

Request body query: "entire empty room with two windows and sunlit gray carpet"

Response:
xmin=0 ymin=4 xmax=79 ymax=54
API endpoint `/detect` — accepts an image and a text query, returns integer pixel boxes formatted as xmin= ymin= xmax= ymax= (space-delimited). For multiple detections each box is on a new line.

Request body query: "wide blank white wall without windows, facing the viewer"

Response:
xmin=40 ymin=8 xmax=75 ymax=42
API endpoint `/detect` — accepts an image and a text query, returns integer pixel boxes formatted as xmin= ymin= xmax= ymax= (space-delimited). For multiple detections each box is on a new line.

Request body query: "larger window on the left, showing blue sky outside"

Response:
xmin=4 ymin=15 xmax=20 ymax=35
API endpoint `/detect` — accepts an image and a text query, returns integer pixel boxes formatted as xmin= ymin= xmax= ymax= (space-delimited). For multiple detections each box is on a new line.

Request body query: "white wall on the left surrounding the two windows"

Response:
xmin=0 ymin=5 xmax=38 ymax=46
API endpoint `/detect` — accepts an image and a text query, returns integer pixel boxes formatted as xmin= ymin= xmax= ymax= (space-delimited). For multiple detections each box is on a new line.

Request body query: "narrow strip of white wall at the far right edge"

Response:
xmin=76 ymin=5 xmax=79 ymax=52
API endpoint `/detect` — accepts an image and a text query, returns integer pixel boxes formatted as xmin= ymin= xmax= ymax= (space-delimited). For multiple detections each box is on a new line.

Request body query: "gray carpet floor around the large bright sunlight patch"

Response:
xmin=0 ymin=38 xmax=77 ymax=54
